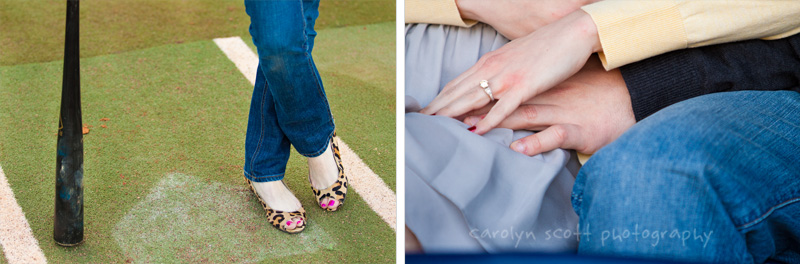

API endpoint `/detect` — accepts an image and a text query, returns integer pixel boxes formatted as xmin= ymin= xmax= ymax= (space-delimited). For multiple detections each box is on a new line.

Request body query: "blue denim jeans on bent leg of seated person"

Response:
xmin=572 ymin=91 xmax=800 ymax=263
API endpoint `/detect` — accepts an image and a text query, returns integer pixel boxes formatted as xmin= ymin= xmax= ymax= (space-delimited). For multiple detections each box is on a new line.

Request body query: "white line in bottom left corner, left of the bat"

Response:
xmin=0 ymin=164 xmax=47 ymax=264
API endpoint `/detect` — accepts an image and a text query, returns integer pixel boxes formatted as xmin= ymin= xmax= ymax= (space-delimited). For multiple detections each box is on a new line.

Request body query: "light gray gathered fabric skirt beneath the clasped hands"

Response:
xmin=405 ymin=24 xmax=579 ymax=253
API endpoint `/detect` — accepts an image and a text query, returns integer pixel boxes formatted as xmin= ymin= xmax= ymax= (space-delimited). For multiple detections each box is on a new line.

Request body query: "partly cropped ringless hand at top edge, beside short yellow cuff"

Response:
xmin=456 ymin=0 xmax=597 ymax=40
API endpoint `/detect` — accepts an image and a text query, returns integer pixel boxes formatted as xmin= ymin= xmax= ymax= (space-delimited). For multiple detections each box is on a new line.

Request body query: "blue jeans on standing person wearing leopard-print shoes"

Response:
xmin=244 ymin=0 xmax=334 ymax=182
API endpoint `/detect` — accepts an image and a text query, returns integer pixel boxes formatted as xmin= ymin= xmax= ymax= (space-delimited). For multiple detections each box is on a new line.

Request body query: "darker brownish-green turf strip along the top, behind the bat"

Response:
xmin=0 ymin=0 xmax=395 ymax=65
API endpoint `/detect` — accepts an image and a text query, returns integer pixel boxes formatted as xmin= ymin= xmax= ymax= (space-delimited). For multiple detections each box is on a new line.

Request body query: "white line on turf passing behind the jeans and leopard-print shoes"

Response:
xmin=214 ymin=37 xmax=397 ymax=232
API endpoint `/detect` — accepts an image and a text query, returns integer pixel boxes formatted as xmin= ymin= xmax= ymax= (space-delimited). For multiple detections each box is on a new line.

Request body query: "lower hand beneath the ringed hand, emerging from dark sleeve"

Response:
xmin=464 ymin=56 xmax=636 ymax=156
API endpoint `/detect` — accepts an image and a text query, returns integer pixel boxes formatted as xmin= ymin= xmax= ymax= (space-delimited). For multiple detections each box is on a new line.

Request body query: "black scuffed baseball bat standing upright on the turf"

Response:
xmin=53 ymin=0 xmax=83 ymax=247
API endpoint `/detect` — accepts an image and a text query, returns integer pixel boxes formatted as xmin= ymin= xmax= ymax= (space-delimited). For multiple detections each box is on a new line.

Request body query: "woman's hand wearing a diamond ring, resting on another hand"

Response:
xmin=420 ymin=10 xmax=601 ymax=135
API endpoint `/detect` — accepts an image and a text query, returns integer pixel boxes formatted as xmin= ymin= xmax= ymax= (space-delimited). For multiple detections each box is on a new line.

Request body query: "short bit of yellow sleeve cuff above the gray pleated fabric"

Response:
xmin=405 ymin=0 xmax=477 ymax=27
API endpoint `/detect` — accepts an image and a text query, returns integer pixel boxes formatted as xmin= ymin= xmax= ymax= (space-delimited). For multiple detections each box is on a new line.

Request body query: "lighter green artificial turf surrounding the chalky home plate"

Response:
xmin=0 ymin=21 xmax=395 ymax=263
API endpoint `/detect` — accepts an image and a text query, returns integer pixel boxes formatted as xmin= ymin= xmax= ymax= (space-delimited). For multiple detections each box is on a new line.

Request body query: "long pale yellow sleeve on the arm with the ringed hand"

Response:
xmin=582 ymin=0 xmax=800 ymax=70
